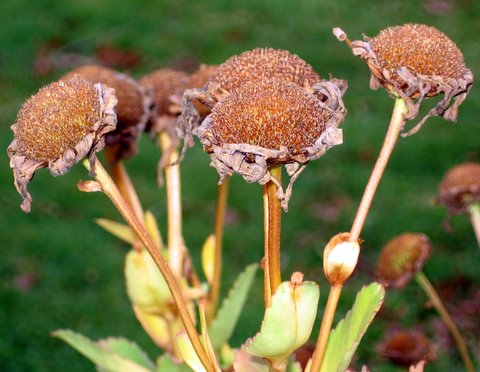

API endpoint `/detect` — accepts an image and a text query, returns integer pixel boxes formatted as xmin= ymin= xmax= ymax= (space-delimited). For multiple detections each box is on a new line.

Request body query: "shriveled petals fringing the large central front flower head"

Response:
xmin=194 ymin=79 xmax=347 ymax=211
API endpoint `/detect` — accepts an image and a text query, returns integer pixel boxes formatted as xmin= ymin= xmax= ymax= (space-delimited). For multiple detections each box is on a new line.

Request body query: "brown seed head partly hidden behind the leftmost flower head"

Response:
xmin=60 ymin=65 xmax=148 ymax=130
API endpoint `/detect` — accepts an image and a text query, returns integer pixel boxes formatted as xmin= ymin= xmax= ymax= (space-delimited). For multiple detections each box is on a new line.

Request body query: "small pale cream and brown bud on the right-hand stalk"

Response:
xmin=323 ymin=233 xmax=360 ymax=285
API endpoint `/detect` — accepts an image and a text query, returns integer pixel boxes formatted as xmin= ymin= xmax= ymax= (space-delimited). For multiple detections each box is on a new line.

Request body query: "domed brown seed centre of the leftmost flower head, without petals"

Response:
xmin=13 ymin=78 xmax=101 ymax=162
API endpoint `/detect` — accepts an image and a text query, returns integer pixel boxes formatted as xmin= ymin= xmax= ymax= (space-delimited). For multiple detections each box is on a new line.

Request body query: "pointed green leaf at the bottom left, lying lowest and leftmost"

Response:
xmin=52 ymin=329 xmax=151 ymax=372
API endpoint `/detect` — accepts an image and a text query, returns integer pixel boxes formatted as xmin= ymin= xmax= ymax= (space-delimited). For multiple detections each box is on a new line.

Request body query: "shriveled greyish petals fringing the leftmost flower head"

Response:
xmin=7 ymin=84 xmax=117 ymax=213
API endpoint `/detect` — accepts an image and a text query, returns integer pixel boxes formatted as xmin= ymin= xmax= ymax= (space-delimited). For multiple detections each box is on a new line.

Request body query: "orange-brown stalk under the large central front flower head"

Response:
xmin=263 ymin=165 xmax=282 ymax=307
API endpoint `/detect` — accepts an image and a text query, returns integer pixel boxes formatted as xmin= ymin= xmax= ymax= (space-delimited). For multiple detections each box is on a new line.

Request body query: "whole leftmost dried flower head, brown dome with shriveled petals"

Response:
xmin=7 ymin=76 xmax=117 ymax=212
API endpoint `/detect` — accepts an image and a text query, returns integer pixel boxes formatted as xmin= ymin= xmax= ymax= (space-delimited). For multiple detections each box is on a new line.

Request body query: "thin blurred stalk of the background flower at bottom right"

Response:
xmin=415 ymin=271 xmax=475 ymax=372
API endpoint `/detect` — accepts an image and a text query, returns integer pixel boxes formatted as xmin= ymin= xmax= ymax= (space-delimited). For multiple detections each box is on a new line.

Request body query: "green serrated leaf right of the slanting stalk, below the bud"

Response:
xmin=321 ymin=283 xmax=385 ymax=372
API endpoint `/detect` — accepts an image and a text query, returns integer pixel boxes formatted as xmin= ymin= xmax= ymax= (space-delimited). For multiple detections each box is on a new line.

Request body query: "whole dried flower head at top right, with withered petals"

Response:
xmin=334 ymin=24 xmax=473 ymax=135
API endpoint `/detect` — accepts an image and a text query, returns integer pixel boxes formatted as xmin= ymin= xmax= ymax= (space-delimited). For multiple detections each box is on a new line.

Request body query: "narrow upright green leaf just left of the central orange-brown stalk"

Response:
xmin=208 ymin=264 xmax=258 ymax=350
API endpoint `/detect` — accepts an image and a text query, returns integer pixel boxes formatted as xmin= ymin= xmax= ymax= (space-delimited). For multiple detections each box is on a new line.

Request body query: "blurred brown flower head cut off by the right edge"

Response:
xmin=437 ymin=163 xmax=480 ymax=214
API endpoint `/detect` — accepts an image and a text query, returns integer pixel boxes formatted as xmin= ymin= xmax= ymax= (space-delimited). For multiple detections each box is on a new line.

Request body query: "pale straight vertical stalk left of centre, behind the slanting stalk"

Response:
xmin=159 ymin=131 xmax=186 ymax=278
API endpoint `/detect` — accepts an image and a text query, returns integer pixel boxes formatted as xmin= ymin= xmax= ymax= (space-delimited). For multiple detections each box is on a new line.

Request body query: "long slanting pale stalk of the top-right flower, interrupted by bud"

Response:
xmin=311 ymin=98 xmax=407 ymax=372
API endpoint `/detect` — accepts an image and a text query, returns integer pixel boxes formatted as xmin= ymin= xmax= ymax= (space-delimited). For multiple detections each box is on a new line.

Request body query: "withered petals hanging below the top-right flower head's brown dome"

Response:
xmin=350 ymin=36 xmax=473 ymax=137
